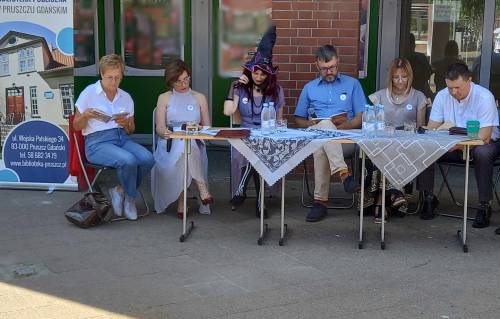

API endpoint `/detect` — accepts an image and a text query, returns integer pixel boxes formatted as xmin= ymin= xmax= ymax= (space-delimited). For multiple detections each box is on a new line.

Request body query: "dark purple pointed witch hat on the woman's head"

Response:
xmin=243 ymin=25 xmax=278 ymax=74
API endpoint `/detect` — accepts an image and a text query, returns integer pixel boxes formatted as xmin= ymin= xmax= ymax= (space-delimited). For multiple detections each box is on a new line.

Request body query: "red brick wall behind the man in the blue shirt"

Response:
xmin=272 ymin=0 xmax=359 ymax=178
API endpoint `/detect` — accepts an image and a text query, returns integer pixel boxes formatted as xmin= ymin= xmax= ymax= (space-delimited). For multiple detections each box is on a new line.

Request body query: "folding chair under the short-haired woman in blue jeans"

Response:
xmin=72 ymin=126 xmax=150 ymax=222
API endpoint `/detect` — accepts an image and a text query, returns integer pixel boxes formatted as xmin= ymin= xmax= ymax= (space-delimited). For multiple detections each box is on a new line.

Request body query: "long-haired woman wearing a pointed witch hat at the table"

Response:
xmin=224 ymin=26 xmax=285 ymax=218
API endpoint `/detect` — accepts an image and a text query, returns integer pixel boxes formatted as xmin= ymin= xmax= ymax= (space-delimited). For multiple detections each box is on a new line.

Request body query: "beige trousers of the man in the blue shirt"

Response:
xmin=311 ymin=120 xmax=354 ymax=201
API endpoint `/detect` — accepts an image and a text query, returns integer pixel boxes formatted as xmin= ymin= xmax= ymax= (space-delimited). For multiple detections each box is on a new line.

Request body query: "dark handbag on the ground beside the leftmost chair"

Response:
xmin=64 ymin=192 xmax=111 ymax=228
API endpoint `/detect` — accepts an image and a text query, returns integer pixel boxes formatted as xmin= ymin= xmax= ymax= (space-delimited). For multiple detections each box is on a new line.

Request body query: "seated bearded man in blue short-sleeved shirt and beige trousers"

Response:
xmin=294 ymin=44 xmax=366 ymax=222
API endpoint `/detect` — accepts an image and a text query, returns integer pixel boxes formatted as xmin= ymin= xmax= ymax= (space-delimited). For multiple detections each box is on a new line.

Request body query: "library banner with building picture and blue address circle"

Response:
xmin=0 ymin=0 xmax=79 ymax=189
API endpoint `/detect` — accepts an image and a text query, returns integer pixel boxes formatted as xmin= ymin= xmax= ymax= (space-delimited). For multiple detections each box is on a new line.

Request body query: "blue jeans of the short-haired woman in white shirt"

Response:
xmin=85 ymin=128 xmax=154 ymax=198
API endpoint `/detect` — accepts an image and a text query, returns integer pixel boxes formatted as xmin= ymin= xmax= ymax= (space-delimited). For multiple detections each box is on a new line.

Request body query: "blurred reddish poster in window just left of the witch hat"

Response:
xmin=219 ymin=0 xmax=272 ymax=77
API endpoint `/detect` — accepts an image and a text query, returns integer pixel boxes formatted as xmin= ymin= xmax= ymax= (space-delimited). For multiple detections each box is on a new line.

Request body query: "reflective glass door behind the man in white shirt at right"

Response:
xmin=399 ymin=0 xmax=484 ymax=99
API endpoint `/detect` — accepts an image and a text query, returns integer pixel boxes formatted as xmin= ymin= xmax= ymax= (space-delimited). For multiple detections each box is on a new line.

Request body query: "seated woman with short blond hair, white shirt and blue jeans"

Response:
xmin=73 ymin=54 xmax=154 ymax=220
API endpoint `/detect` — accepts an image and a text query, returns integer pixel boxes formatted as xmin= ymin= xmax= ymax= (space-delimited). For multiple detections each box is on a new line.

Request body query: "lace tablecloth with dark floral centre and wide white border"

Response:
xmin=229 ymin=129 xmax=360 ymax=185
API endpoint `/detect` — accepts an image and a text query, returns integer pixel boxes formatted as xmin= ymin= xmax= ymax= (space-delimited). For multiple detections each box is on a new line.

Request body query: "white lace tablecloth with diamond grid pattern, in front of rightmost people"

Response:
xmin=353 ymin=131 xmax=468 ymax=188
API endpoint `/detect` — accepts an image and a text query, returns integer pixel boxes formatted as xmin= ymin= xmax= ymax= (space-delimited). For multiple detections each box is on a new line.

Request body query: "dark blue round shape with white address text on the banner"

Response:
xmin=3 ymin=120 xmax=69 ymax=183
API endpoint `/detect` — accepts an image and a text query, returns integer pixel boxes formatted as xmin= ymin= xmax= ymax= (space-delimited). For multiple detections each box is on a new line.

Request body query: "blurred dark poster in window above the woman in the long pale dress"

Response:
xmin=121 ymin=0 xmax=184 ymax=76
